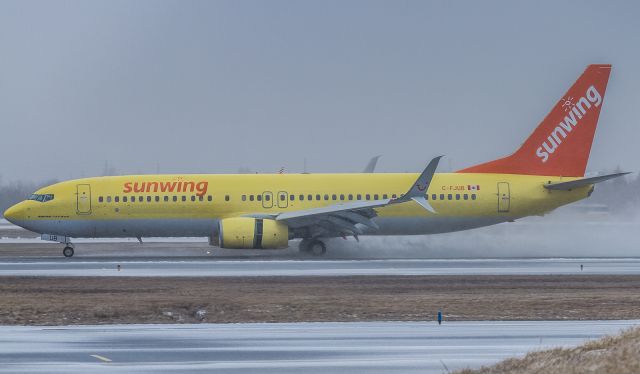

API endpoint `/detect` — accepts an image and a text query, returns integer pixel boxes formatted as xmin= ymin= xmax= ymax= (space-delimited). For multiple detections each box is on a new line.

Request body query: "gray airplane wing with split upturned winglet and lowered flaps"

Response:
xmin=274 ymin=156 xmax=442 ymax=238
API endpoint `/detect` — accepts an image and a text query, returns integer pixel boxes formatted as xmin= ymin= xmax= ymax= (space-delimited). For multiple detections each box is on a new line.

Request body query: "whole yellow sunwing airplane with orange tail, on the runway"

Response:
xmin=4 ymin=64 xmax=627 ymax=257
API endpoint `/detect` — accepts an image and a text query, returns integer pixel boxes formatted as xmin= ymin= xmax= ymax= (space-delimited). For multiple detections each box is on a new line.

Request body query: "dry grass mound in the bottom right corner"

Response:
xmin=458 ymin=327 xmax=640 ymax=374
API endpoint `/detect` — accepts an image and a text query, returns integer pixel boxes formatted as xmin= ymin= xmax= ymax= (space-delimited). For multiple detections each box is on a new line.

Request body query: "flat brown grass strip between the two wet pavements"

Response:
xmin=0 ymin=275 xmax=640 ymax=325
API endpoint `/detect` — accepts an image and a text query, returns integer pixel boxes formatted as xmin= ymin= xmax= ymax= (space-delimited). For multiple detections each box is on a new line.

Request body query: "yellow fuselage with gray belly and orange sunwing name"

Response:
xmin=5 ymin=173 xmax=592 ymax=238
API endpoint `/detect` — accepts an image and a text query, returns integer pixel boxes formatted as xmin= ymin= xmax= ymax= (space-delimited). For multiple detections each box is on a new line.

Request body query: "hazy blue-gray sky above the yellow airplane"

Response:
xmin=0 ymin=0 xmax=640 ymax=181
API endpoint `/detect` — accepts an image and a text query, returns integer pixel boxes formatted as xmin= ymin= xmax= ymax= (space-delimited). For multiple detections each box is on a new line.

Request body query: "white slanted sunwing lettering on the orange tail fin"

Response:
xmin=536 ymin=86 xmax=602 ymax=162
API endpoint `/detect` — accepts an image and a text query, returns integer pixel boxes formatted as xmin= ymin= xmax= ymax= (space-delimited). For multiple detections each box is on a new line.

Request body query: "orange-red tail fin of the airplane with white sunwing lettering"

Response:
xmin=458 ymin=65 xmax=611 ymax=177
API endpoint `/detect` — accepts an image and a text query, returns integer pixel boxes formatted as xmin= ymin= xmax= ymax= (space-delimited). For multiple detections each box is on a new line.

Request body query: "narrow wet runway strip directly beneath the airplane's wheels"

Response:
xmin=0 ymin=257 xmax=640 ymax=277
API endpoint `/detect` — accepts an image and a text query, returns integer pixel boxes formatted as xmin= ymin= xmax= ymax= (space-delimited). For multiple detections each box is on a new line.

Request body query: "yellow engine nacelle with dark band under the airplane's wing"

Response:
xmin=218 ymin=217 xmax=289 ymax=249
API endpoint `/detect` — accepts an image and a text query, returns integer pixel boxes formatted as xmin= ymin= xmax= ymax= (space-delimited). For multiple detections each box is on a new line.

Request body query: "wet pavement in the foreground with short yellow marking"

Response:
xmin=0 ymin=321 xmax=640 ymax=373
